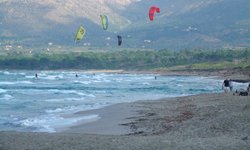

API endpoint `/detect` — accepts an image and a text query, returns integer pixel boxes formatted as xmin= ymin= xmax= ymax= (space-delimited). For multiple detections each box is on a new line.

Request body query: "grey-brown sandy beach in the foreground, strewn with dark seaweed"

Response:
xmin=0 ymin=93 xmax=250 ymax=150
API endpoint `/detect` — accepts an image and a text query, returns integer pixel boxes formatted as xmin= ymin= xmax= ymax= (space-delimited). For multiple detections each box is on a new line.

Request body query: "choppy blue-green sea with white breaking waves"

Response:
xmin=0 ymin=71 xmax=247 ymax=133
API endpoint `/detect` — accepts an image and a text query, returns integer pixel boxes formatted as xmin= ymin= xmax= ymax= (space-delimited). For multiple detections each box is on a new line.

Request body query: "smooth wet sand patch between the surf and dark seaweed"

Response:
xmin=58 ymin=102 xmax=145 ymax=135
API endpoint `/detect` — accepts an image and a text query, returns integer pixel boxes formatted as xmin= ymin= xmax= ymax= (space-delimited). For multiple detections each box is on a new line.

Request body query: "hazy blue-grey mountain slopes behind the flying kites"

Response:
xmin=0 ymin=0 xmax=250 ymax=50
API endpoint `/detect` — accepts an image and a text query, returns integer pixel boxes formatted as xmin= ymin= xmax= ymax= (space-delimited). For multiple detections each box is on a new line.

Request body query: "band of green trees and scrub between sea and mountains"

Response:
xmin=0 ymin=49 xmax=250 ymax=70
